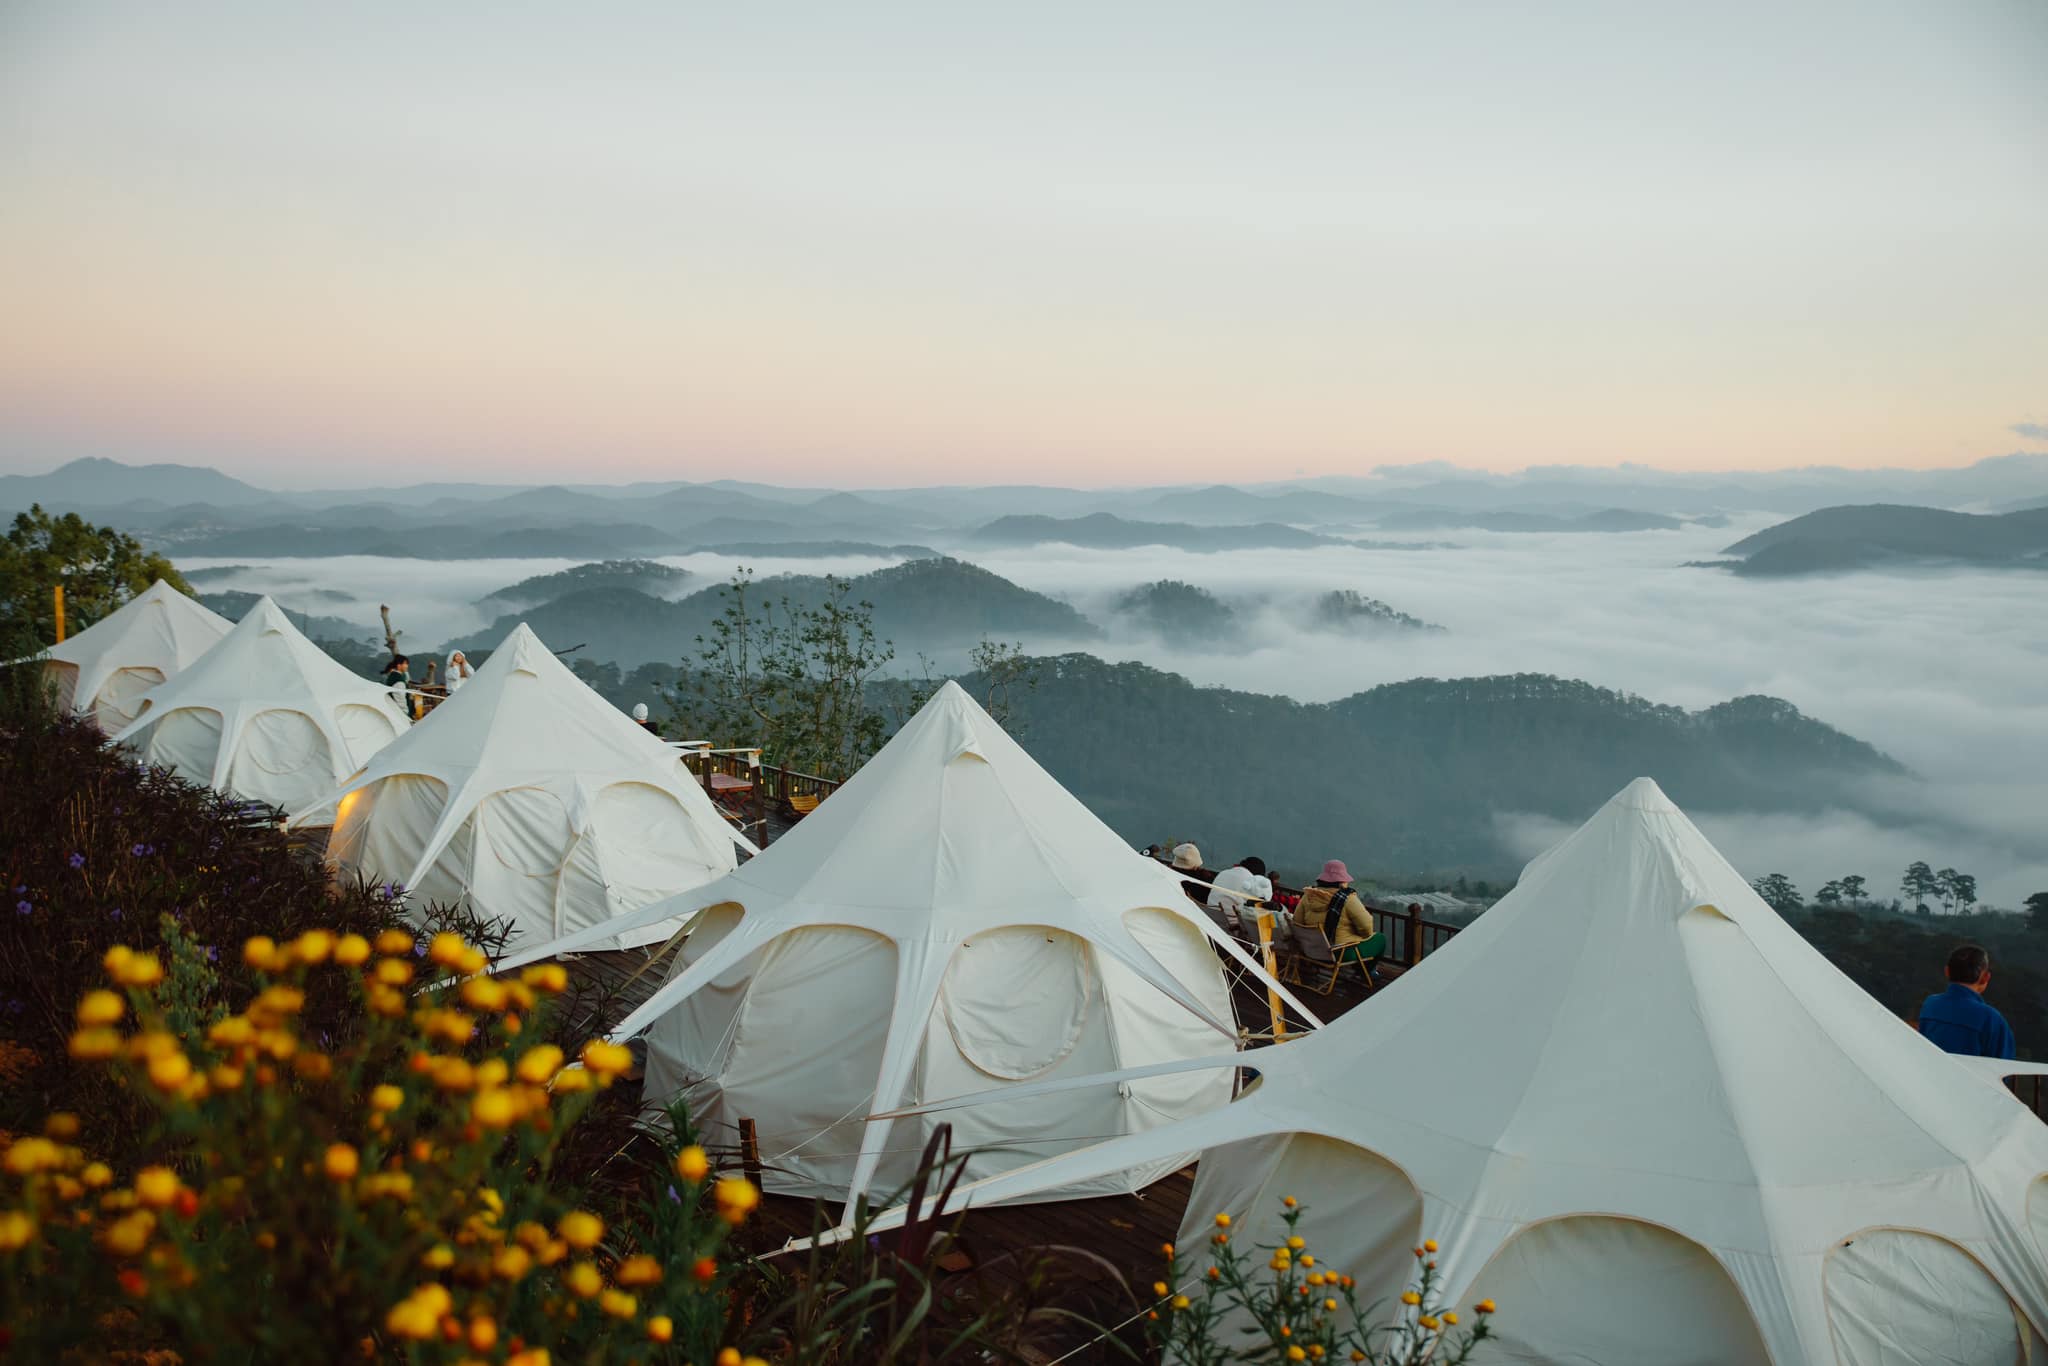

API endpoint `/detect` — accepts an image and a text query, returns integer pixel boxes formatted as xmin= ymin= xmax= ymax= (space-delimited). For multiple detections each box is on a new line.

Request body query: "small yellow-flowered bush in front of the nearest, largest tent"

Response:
xmin=1145 ymin=1196 xmax=1493 ymax=1366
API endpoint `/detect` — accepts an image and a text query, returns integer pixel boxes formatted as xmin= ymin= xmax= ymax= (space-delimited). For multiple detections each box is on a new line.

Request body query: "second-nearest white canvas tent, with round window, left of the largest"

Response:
xmin=512 ymin=684 xmax=1313 ymax=1200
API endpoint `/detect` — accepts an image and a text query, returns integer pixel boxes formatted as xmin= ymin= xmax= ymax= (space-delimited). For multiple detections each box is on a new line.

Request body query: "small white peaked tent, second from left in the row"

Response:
xmin=115 ymin=598 xmax=406 ymax=811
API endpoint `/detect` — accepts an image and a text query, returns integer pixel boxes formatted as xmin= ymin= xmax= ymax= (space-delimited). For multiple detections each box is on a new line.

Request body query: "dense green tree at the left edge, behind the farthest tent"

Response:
xmin=0 ymin=506 xmax=193 ymax=645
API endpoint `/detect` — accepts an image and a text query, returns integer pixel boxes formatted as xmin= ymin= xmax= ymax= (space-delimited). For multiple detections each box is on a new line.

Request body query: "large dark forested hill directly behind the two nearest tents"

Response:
xmin=991 ymin=655 xmax=1905 ymax=877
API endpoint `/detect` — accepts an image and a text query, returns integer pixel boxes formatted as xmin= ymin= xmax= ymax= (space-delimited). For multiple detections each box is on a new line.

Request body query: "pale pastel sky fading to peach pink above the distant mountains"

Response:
xmin=0 ymin=0 xmax=2048 ymax=485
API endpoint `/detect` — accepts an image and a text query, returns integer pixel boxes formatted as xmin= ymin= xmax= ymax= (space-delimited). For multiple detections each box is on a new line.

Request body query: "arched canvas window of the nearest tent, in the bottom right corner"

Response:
xmin=1827 ymin=1229 xmax=2025 ymax=1366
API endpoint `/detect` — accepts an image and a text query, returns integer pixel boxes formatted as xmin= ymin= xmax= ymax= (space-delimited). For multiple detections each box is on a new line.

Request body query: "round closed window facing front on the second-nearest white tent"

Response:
xmin=938 ymin=926 xmax=1096 ymax=1081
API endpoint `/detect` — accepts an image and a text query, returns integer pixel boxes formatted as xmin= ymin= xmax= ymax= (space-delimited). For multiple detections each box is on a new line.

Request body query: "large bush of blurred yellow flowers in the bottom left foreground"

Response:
xmin=0 ymin=926 xmax=778 ymax=1366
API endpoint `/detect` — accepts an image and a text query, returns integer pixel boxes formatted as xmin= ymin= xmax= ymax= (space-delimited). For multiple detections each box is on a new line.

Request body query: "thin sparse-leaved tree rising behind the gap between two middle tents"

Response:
xmin=678 ymin=569 xmax=895 ymax=778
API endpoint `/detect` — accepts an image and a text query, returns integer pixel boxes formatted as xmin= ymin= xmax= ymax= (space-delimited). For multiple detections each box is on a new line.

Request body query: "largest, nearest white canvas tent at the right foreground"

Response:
xmin=883 ymin=778 xmax=2048 ymax=1366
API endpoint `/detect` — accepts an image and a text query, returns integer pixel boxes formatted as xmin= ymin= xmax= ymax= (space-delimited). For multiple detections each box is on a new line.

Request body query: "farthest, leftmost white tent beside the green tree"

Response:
xmin=28 ymin=580 xmax=233 ymax=735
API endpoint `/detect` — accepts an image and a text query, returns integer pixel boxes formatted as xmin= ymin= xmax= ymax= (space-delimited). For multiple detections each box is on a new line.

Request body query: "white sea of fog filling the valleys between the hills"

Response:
xmin=188 ymin=518 xmax=2048 ymax=905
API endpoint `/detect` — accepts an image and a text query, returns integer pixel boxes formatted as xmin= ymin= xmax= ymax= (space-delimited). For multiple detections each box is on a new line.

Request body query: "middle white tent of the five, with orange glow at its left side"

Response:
xmin=295 ymin=625 xmax=739 ymax=946
